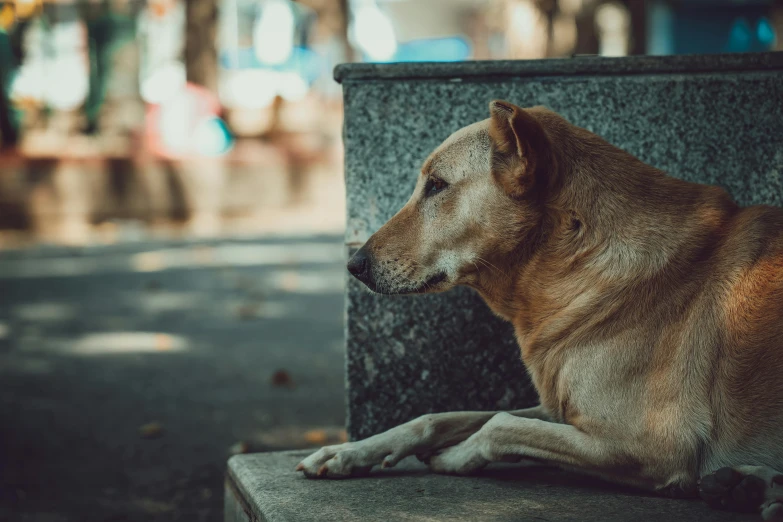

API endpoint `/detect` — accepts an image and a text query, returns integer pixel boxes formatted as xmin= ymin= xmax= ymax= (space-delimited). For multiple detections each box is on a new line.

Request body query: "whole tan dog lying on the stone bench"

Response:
xmin=299 ymin=102 xmax=783 ymax=519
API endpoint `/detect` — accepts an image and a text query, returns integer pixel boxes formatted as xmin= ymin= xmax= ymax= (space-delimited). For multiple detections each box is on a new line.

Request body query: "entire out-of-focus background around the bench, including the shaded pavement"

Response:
xmin=0 ymin=0 xmax=783 ymax=521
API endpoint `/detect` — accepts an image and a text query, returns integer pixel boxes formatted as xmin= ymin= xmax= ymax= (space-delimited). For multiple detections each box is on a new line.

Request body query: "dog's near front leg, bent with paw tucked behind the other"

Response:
xmin=429 ymin=413 xmax=659 ymax=489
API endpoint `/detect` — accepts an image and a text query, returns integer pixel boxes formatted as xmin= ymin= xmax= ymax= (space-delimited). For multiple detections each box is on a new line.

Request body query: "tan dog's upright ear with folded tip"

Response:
xmin=489 ymin=100 xmax=551 ymax=198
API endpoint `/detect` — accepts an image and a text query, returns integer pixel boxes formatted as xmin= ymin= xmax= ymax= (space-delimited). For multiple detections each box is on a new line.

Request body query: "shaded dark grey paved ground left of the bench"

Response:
xmin=0 ymin=237 xmax=344 ymax=522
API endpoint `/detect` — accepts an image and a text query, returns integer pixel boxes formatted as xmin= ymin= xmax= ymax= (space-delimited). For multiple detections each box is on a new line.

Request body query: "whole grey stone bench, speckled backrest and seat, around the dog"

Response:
xmin=226 ymin=53 xmax=783 ymax=521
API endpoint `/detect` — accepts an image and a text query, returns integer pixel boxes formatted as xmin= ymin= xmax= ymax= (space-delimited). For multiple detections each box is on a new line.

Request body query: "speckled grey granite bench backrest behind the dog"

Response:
xmin=338 ymin=53 xmax=783 ymax=438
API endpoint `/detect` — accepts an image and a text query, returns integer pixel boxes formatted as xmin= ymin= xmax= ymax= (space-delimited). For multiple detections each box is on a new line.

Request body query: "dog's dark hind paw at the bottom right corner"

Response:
xmin=699 ymin=466 xmax=783 ymax=521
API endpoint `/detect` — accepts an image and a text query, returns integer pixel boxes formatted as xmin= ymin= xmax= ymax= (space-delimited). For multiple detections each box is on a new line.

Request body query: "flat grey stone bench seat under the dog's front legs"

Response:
xmin=225 ymin=451 xmax=760 ymax=522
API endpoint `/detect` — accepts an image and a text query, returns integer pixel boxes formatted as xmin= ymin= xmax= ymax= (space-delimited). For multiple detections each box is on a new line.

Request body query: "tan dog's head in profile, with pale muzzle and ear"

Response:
xmin=348 ymin=101 xmax=552 ymax=294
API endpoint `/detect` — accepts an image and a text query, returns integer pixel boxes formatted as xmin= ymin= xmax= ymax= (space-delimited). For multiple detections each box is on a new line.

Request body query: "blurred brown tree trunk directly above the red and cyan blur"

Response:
xmin=185 ymin=0 xmax=218 ymax=94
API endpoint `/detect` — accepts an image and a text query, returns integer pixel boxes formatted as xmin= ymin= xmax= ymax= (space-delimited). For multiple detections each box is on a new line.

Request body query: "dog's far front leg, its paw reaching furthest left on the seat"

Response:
xmin=296 ymin=406 xmax=549 ymax=478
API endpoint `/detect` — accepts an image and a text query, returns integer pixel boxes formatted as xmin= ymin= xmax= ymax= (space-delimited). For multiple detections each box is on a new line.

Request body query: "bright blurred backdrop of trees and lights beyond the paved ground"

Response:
xmin=0 ymin=0 xmax=783 ymax=247
